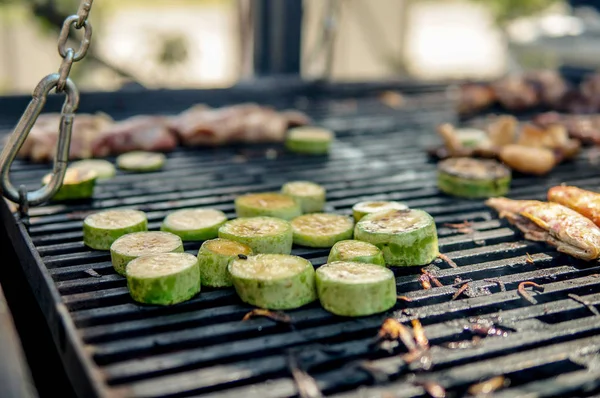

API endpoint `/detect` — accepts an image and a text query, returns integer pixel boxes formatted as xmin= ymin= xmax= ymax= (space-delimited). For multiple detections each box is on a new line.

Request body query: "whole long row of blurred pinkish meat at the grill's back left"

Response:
xmin=14 ymin=104 xmax=311 ymax=162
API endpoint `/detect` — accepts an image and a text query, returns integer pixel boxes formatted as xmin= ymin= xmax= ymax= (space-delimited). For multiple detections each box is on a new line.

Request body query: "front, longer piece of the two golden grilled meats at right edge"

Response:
xmin=485 ymin=198 xmax=600 ymax=261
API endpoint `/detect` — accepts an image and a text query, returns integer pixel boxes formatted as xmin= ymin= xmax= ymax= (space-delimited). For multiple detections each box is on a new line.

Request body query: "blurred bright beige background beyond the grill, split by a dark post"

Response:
xmin=0 ymin=0 xmax=600 ymax=95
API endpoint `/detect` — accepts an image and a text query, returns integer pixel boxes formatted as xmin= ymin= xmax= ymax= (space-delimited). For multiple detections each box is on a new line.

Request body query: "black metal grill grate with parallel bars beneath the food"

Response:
xmin=0 ymin=83 xmax=600 ymax=398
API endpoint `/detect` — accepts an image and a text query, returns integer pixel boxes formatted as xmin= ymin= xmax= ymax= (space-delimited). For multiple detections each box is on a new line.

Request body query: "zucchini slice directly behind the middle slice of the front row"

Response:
xmin=219 ymin=217 xmax=293 ymax=254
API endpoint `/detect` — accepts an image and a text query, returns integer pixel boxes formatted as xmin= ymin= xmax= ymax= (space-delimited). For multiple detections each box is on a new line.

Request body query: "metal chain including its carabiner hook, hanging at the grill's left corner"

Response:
xmin=0 ymin=0 xmax=93 ymax=212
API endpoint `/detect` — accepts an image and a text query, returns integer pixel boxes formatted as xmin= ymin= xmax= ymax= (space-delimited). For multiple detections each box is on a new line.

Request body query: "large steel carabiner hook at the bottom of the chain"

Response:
xmin=0 ymin=73 xmax=79 ymax=206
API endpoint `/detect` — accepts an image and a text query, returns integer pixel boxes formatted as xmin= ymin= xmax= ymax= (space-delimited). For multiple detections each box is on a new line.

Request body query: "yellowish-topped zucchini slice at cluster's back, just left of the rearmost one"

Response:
xmin=235 ymin=192 xmax=302 ymax=220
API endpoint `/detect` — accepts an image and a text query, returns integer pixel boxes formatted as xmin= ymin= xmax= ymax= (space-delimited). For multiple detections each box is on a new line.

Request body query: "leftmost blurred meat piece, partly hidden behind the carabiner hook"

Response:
xmin=19 ymin=113 xmax=114 ymax=162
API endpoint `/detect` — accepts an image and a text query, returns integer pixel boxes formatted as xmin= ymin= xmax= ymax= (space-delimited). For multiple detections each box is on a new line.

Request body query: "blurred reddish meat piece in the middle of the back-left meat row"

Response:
xmin=91 ymin=116 xmax=177 ymax=157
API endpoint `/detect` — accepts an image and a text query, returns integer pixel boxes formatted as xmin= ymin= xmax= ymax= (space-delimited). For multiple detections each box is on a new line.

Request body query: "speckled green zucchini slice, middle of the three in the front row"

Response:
xmin=229 ymin=254 xmax=317 ymax=310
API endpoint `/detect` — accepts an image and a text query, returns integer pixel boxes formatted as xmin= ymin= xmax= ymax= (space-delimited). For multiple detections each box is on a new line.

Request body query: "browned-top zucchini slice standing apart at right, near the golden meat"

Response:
xmin=438 ymin=158 xmax=511 ymax=198
